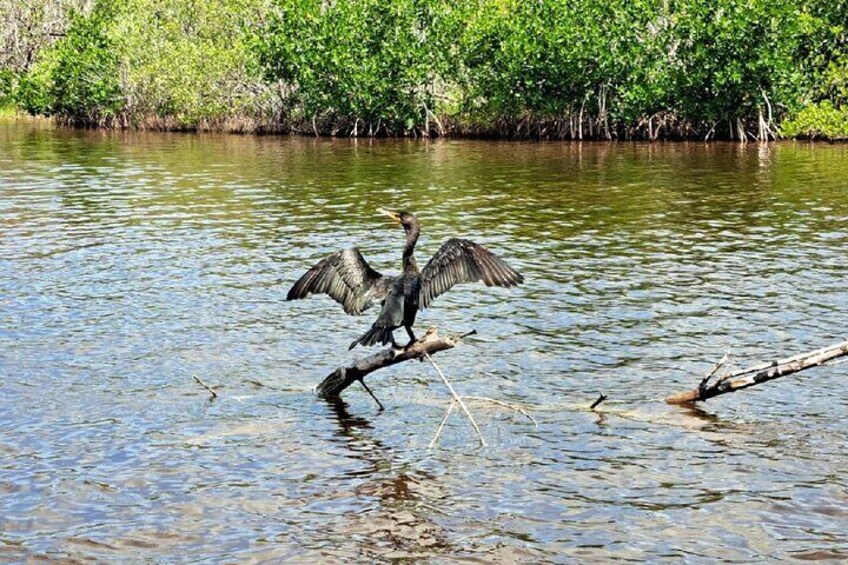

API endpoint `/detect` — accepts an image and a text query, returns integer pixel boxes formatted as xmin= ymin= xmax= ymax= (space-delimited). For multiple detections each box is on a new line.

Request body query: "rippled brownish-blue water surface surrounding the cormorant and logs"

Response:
xmin=0 ymin=121 xmax=848 ymax=563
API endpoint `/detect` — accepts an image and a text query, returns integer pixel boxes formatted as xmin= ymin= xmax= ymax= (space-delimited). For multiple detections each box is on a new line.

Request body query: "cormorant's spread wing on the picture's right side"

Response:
xmin=419 ymin=238 xmax=524 ymax=309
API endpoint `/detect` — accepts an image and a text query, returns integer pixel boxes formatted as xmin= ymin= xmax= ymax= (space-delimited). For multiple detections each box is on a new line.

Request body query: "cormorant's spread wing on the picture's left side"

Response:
xmin=286 ymin=247 xmax=394 ymax=316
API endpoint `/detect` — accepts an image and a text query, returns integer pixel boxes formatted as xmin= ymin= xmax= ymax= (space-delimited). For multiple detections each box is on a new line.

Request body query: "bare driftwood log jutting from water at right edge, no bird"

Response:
xmin=665 ymin=341 xmax=848 ymax=404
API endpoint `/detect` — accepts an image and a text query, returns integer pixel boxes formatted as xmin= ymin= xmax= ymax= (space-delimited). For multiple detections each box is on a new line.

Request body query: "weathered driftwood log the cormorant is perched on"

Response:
xmin=316 ymin=328 xmax=475 ymax=408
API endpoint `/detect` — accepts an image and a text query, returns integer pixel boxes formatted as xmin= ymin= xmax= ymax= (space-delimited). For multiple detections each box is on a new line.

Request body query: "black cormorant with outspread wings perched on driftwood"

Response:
xmin=286 ymin=210 xmax=524 ymax=349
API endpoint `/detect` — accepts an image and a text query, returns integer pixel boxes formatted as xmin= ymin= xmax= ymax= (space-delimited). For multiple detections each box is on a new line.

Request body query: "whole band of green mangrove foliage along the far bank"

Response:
xmin=0 ymin=0 xmax=848 ymax=138
